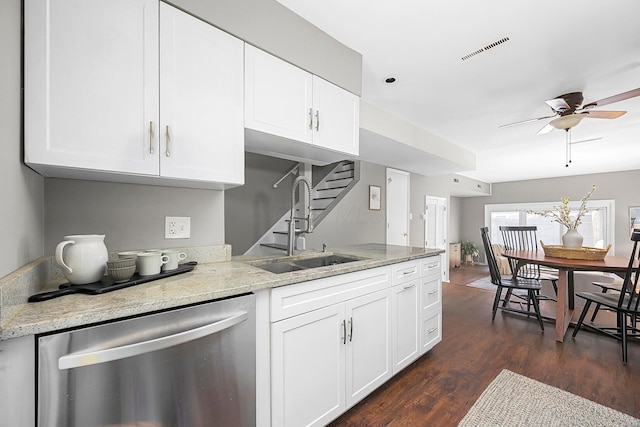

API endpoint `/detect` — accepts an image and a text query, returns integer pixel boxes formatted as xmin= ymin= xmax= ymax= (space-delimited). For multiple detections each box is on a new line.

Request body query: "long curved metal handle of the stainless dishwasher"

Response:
xmin=58 ymin=311 xmax=249 ymax=370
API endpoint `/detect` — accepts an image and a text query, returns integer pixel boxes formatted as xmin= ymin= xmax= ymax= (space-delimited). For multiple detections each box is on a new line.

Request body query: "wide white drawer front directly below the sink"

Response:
xmin=271 ymin=267 xmax=391 ymax=322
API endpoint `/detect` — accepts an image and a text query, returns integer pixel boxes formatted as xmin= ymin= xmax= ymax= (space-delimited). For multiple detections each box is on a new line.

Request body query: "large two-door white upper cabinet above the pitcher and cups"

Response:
xmin=25 ymin=0 xmax=244 ymax=188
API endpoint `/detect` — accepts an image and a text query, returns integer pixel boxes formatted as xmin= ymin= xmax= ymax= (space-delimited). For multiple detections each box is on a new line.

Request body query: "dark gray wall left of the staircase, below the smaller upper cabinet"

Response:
xmin=225 ymin=152 xmax=297 ymax=255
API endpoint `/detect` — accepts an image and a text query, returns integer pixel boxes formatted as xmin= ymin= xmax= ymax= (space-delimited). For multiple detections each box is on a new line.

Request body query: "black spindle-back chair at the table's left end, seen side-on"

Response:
xmin=480 ymin=227 xmax=544 ymax=331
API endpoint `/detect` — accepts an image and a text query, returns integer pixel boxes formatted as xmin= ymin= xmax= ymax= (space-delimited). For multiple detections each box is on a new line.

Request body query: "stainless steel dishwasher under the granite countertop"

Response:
xmin=37 ymin=294 xmax=256 ymax=427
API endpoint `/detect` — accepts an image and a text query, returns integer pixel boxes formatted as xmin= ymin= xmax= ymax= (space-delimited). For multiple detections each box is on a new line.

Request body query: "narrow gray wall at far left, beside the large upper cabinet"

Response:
xmin=0 ymin=0 xmax=44 ymax=277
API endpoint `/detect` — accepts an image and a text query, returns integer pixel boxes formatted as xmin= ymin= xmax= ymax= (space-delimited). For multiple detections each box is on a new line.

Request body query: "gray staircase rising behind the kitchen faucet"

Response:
xmin=245 ymin=160 xmax=360 ymax=255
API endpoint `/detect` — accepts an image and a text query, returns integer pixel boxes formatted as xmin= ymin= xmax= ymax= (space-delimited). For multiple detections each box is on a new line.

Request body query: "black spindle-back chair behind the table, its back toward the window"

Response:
xmin=499 ymin=225 xmax=558 ymax=301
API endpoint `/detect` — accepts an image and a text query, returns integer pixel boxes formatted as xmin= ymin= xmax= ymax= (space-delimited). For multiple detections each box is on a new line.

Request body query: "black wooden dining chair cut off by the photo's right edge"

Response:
xmin=572 ymin=231 xmax=640 ymax=363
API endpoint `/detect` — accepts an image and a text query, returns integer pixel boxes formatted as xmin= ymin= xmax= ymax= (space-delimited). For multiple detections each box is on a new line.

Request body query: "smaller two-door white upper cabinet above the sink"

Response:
xmin=245 ymin=45 xmax=360 ymax=164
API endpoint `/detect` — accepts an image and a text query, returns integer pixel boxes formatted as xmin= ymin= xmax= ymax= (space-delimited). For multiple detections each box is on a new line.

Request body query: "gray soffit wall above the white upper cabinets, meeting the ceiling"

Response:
xmin=171 ymin=0 xmax=362 ymax=95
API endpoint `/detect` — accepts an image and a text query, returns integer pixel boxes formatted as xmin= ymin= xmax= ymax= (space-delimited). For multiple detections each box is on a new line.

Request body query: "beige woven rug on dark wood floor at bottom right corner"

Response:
xmin=459 ymin=369 xmax=640 ymax=427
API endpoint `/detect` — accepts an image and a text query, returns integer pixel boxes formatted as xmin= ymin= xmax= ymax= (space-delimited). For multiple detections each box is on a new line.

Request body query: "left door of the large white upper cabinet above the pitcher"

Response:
xmin=24 ymin=0 xmax=159 ymax=175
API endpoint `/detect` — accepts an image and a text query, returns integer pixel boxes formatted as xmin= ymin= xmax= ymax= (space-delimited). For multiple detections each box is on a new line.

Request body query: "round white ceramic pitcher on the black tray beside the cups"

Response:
xmin=55 ymin=234 xmax=108 ymax=285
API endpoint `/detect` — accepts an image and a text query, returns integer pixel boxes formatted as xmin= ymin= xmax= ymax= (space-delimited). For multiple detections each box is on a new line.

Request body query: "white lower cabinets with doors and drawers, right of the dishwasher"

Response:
xmin=258 ymin=256 xmax=442 ymax=427
